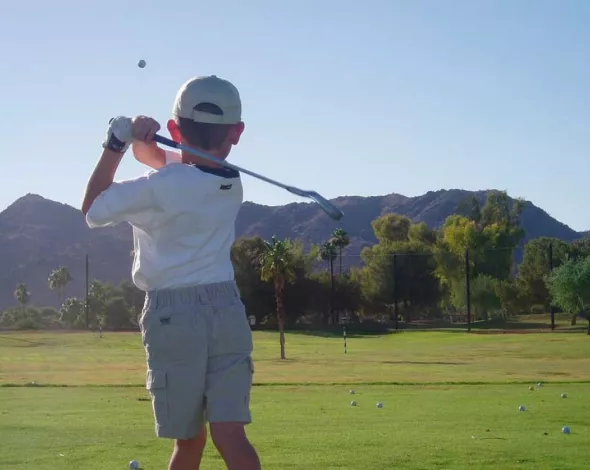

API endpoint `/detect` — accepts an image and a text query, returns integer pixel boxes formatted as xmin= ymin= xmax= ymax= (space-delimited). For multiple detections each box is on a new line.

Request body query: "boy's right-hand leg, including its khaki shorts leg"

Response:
xmin=205 ymin=283 xmax=260 ymax=470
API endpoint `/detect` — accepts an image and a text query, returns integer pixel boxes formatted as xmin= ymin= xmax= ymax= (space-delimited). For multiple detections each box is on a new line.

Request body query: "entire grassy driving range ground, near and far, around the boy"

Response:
xmin=0 ymin=332 xmax=590 ymax=470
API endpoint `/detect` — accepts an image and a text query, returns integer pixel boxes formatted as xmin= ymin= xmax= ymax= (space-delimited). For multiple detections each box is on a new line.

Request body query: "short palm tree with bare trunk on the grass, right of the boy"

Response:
xmin=260 ymin=236 xmax=295 ymax=359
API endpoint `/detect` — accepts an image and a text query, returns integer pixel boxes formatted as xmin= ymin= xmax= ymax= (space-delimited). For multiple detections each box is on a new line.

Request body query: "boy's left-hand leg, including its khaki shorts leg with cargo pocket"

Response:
xmin=140 ymin=290 xmax=207 ymax=470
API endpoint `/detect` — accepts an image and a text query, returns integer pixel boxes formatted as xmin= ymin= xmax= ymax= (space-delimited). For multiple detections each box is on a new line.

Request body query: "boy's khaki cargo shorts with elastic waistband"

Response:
xmin=139 ymin=282 xmax=254 ymax=439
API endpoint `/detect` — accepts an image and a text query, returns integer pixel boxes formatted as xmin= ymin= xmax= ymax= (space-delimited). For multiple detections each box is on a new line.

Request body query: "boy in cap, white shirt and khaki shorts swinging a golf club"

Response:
xmin=82 ymin=76 xmax=260 ymax=470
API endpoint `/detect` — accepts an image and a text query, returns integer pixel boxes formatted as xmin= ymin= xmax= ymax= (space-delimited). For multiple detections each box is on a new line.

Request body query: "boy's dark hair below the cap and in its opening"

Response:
xmin=174 ymin=103 xmax=233 ymax=150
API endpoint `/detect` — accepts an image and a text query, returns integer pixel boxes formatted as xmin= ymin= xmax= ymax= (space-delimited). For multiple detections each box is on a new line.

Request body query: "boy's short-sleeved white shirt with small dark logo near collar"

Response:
xmin=86 ymin=152 xmax=243 ymax=291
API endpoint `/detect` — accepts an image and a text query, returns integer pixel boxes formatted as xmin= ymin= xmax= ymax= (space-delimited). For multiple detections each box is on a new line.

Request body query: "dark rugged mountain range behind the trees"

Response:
xmin=0 ymin=189 xmax=583 ymax=309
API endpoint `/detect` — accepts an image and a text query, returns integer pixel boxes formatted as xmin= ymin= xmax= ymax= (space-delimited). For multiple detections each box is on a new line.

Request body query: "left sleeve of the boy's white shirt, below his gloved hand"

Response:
xmin=86 ymin=173 xmax=156 ymax=228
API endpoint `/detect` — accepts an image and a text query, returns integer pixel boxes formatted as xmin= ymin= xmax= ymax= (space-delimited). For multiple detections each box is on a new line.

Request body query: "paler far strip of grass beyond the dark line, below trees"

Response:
xmin=0 ymin=332 xmax=590 ymax=385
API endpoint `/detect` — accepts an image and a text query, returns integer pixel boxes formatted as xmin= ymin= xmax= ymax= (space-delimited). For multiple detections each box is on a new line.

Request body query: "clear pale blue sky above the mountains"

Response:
xmin=0 ymin=0 xmax=590 ymax=230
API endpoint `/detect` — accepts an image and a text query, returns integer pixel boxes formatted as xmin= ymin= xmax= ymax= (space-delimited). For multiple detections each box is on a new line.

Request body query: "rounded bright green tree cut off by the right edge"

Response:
xmin=548 ymin=257 xmax=590 ymax=335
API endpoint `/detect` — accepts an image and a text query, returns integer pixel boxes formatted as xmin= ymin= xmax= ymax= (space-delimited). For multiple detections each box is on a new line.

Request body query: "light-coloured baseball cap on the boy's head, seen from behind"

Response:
xmin=172 ymin=75 xmax=242 ymax=124
